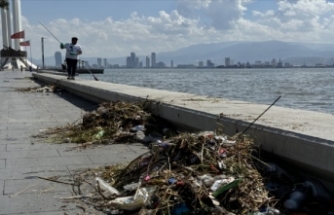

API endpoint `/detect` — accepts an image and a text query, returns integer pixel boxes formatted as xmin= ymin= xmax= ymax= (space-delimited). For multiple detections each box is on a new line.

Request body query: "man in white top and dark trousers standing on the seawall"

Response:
xmin=60 ymin=37 xmax=82 ymax=80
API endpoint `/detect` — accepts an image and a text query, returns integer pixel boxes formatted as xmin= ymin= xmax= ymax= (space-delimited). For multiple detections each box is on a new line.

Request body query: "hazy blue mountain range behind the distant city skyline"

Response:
xmin=34 ymin=41 xmax=334 ymax=66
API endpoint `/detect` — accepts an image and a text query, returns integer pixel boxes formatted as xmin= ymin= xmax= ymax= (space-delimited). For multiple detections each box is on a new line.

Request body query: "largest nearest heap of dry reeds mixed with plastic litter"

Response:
xmin=60 ymin=132 xmax=279 ymax=214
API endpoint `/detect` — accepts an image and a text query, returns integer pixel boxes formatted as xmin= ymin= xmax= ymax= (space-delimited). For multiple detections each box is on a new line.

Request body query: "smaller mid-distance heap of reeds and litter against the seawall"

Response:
xmin=35 ymin=100 xmax=176 ymax=144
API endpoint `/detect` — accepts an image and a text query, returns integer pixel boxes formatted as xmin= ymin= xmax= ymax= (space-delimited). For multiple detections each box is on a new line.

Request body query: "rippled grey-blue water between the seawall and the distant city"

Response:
xmin=80 ymin=68 xmax=334 ymax=113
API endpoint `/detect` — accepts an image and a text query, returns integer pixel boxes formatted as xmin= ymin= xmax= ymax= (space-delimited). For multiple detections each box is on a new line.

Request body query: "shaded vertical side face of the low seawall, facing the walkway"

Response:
xmin=33 ymin=73 xmax=334 ymax=191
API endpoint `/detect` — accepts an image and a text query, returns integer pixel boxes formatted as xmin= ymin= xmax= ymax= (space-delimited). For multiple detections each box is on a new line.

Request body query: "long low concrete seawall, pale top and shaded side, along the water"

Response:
xmin=33 ymin=73 xmax=334 ymax=190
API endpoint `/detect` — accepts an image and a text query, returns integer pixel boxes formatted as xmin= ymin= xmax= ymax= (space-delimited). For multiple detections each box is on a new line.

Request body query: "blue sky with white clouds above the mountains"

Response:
xmin=0 ymin=0 xmax=334 ymax=58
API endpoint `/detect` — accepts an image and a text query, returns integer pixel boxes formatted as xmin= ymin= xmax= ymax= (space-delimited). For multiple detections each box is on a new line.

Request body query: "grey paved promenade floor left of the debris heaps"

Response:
xmin=0 ymin=71 xmax=146 ymax=215
